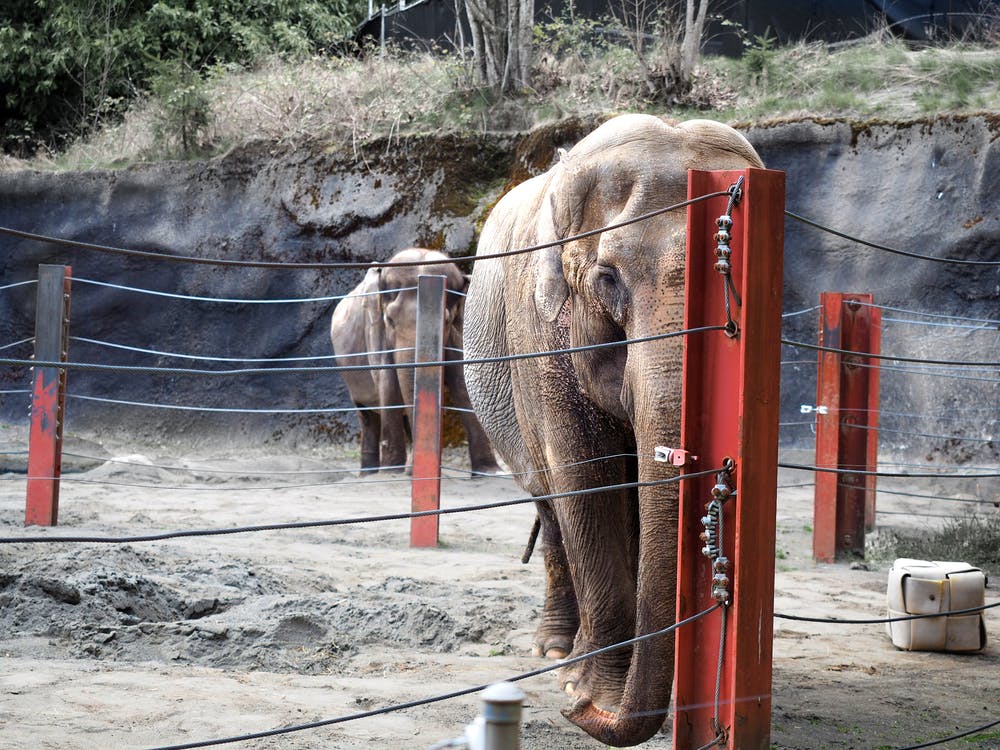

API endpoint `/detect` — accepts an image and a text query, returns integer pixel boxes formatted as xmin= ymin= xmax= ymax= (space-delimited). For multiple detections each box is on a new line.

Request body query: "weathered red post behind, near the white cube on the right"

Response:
xmin=813 ymin=292 xmax=882 ymax=563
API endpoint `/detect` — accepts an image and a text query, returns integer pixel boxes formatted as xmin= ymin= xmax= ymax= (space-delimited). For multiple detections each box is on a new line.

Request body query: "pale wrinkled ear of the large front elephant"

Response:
xmin=535 ymin=165 xmax=578 ymax=323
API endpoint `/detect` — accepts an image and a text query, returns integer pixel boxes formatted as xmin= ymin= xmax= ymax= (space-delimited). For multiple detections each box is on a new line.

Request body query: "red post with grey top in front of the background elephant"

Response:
xmin=410 ymin=276 xmax=445 ymax=547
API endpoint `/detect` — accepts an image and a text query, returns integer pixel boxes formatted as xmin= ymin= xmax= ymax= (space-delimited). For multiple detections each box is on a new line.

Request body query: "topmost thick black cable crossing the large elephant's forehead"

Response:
xmin=0 ymin=190 xmax=728 ymax=269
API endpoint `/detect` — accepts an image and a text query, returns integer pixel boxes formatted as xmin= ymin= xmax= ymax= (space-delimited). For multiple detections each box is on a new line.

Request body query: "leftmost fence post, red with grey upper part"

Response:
xmin=24 ymin=265 xmax=71 ymax=526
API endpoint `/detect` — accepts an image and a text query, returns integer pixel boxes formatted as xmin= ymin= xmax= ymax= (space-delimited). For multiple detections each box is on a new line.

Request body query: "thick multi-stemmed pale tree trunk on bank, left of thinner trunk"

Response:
xmin=465 ymin=0 xmax=535 ymax=94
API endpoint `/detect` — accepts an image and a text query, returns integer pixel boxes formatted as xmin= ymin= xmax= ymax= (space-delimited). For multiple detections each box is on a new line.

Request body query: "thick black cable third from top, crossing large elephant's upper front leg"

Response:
xmin=0 ymin=469 xmax=719 ymax=544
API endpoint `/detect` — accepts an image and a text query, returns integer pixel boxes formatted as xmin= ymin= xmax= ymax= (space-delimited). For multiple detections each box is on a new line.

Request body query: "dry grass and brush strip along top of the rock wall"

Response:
xmin=8 ymin=30 xmax=1000 ymax=169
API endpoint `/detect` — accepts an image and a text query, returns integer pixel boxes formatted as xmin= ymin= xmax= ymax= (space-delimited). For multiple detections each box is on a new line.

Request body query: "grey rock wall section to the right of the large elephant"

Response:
xmin=747 ymin=116 xmax=1000 ymax=464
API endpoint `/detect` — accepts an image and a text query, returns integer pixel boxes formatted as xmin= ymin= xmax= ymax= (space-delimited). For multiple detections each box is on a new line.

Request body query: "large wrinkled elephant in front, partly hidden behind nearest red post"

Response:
xmin=465 ymin=115 xmax=762 ymax=747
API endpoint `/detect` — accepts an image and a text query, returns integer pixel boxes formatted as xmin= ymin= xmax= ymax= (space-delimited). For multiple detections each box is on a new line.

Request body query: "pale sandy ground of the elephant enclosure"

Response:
xmin=0 ymin=434 xmax=1000 ymax=750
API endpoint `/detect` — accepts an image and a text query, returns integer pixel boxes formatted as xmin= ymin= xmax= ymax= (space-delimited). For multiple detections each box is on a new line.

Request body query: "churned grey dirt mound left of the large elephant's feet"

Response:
xmin=0 ymin=545 xmax=511 ymax=673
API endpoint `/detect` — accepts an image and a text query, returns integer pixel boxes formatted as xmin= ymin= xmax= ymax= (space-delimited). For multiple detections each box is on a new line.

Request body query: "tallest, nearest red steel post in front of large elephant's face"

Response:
xmin=673 ymin=169 xmax=785 ymax=750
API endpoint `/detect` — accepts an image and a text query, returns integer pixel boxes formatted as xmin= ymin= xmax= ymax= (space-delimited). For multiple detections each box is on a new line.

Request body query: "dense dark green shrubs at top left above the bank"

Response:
xmin=0 ymin=0 xmax=360 ymax=153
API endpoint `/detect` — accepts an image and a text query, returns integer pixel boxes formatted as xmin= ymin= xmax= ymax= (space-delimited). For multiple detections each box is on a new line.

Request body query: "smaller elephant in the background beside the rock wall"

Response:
xmin=330 ymin=248 xmax=499 ymax=473
